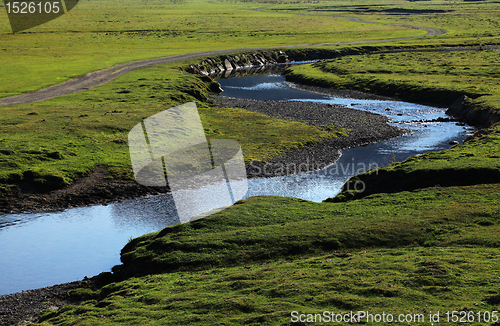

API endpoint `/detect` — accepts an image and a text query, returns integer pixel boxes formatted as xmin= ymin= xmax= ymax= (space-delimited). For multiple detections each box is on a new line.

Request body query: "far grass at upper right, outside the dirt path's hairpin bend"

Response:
xmin=269 ymin=0 xmax=500 ymax=45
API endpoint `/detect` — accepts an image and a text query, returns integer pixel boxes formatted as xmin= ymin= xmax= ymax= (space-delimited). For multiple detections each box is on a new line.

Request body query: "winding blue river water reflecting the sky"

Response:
xmin=0 ymin=74 xmax=472 ymax=295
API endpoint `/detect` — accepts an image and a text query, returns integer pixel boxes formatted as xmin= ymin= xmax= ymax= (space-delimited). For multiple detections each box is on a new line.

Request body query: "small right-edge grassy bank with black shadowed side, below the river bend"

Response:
xmin=328 ymin=126 xmax=500 ymax=201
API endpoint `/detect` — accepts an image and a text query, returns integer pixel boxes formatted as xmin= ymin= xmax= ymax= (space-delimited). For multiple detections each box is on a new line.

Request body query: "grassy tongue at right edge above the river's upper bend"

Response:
xmin=287 ymin=50 xmax=500 ymax=111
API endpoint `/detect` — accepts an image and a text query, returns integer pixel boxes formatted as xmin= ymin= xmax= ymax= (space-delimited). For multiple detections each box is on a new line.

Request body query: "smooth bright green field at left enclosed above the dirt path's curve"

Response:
xmin=0 ymin=0 xmax=423 ymax=97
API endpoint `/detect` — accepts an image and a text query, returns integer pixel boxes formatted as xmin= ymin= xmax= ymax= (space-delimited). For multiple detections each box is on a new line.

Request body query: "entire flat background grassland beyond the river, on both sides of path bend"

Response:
xmin=0 ymin=0 xmax=500 ymax=97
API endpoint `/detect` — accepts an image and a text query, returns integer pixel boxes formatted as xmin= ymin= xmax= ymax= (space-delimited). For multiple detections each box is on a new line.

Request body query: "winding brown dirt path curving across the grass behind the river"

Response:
xmin=0 ymin=11 xmax=445 ymax=106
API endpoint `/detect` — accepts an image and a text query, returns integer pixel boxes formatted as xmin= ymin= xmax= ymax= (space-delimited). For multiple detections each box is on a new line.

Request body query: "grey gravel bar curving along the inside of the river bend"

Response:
xmin=215 ymin=96 xmax=409 ymax=178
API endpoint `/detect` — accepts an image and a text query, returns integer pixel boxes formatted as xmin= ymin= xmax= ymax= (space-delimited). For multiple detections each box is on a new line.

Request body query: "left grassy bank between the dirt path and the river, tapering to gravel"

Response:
xmin=0 ymin=65 xmax=336 ymax=194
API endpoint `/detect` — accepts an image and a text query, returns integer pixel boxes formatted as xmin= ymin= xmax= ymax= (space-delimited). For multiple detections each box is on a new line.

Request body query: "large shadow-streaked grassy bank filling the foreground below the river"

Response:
xmin=41 ymin=184 xmax=500 ymax=325
